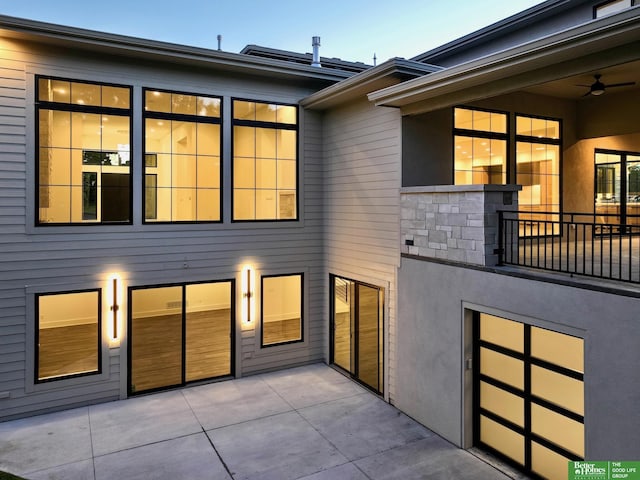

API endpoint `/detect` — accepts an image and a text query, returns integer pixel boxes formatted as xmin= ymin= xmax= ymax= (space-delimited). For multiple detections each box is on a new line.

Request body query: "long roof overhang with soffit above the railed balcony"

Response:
xmin=368 ymin=7 xmax=640 ymax=115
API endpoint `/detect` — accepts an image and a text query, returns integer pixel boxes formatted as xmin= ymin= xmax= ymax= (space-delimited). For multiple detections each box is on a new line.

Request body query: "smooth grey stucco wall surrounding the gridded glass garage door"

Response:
xmin=395 ymin=258 xmax=640 ymax=460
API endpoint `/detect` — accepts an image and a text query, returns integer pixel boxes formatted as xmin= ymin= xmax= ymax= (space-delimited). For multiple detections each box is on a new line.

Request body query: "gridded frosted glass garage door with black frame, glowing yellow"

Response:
xmin=474 ymin=312 xmax=584 ymax=479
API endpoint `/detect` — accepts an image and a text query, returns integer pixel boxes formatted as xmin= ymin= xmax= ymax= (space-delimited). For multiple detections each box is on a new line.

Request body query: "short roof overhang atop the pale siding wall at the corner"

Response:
xmin=300 ymin=58 xmax=442 ymax=110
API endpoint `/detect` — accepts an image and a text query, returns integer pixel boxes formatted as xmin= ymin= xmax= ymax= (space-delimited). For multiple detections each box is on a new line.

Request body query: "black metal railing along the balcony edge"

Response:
xmin=498 ymin=210 xmax=640 ymax=283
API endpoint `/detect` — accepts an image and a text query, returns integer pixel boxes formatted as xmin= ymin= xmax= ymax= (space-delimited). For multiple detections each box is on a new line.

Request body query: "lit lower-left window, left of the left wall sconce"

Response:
xmin=36 ymin=290 xmax=101 ymax=382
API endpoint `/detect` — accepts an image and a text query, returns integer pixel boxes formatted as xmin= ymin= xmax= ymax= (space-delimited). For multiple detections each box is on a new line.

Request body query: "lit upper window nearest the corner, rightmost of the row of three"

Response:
xmin=233 ymin=100 xmax=298 ymax=220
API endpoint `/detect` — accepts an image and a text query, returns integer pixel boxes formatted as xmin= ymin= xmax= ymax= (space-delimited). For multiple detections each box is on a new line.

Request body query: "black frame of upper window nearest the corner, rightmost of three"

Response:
xmin=231 ymin=97 xmax=300 ymax=223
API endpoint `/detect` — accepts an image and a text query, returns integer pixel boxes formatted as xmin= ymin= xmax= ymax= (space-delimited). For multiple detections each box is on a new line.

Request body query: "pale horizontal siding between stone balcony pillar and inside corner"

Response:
xmin=324 ymin=97 xmax=401 ymax=401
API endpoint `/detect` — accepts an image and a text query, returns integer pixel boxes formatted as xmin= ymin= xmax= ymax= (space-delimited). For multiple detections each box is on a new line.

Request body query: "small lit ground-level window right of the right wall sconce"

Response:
xmin=262 ymin=273 xmax=303 ymax=347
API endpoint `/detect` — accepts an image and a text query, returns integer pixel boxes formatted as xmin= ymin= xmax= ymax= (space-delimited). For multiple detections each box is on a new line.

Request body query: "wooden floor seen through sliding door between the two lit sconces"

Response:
xmin=129 ymin=309 xmax=231 ymax=392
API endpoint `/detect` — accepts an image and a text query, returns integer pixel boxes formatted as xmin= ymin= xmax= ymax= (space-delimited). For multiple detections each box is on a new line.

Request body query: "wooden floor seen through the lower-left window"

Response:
xmin=38 ymin=323 xmax=99 ymax=379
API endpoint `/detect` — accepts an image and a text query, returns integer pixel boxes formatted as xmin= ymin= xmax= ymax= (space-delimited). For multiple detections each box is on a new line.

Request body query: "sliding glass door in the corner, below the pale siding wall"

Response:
xmin=331 ymin=276 xmax=383 ymax=393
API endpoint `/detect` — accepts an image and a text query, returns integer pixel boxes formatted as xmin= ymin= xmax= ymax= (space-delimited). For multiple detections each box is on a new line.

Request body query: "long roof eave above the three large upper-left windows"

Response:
xmin=0 ymin=15 xmax=353 ymax=83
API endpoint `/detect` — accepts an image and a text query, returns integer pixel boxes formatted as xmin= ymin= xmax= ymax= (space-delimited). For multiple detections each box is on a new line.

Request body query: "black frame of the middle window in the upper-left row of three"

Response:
xmin=142 ymin=87 xmax=224 ymax=225
